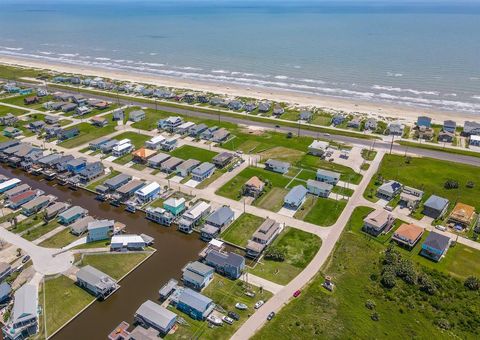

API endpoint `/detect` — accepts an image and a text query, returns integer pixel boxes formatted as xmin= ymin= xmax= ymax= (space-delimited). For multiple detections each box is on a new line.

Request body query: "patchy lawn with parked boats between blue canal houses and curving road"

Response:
xmin=171 ymin=274 xmax=272 ymax=340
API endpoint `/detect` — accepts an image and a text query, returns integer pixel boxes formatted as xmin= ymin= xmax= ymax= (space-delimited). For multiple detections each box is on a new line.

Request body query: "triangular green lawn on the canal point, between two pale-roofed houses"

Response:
xmin=78 ymin=252 xmax=150 ymax=280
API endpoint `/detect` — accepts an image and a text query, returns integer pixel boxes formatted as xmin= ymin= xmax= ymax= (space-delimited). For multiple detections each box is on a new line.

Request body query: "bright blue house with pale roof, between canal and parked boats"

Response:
xmin=177 ymin=288 xmax=215 ymax=320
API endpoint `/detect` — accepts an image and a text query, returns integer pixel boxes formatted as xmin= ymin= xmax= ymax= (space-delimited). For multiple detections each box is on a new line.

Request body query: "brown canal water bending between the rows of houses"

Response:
xmin=0 ymin=165 xmax=205 ymax=340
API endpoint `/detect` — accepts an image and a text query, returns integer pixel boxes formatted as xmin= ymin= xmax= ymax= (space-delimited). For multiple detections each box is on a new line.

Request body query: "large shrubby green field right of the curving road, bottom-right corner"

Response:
xmin=253 ymin=207 xmax=480 ymax=339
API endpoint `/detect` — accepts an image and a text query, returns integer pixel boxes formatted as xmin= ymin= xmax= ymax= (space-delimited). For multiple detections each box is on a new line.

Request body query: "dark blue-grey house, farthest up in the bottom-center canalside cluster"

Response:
xmin=204 ymin=249 xmax=245 ymax=280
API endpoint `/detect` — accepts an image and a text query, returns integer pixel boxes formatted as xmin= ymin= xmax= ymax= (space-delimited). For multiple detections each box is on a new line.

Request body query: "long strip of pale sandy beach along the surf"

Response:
xmin=0 ymin=56 xmax=478 ymax=124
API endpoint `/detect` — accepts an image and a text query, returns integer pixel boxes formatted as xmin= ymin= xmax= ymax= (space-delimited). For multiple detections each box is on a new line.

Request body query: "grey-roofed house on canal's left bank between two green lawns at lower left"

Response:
xmin=77 ymin=266 xmax=119 ymax=299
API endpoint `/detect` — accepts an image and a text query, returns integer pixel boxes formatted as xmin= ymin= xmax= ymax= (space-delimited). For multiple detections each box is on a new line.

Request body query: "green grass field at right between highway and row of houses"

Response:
xmin=364 ymin=155 xmax=480 ymax=211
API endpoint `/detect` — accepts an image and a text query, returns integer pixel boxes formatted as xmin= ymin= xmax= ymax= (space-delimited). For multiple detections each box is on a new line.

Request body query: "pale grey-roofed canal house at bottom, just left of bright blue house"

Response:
xmin=134 ymin=300 xmax=177 ymax=334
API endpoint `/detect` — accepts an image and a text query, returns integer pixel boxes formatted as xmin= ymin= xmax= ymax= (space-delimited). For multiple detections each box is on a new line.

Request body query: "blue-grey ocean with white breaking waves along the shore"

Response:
xmin=0 ymin=0 xmax=480 ymax=113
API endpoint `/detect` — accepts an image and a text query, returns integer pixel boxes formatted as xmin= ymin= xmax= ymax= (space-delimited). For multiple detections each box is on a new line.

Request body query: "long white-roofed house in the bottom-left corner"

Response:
xmin=2 ymin=283 xmax=38 ymax=340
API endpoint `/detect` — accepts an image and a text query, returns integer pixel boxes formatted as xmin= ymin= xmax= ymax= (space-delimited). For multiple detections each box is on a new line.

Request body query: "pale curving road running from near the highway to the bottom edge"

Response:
xmin=232 ymin=152 xmax=384 ymax=340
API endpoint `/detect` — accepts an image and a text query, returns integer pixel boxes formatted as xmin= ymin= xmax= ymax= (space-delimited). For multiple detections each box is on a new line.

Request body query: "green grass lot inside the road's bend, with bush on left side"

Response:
xmin=248 ymin=228 xmax=322 ymax=285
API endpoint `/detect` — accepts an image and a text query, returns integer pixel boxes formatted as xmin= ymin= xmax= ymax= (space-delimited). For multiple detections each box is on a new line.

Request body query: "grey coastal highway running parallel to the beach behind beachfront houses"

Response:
xmin=6 ymin=78 xmax=480 ymax=166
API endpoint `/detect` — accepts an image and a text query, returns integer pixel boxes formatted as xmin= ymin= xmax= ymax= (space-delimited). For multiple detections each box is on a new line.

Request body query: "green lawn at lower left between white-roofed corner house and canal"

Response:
xmin=43 ymin=275 xmax=95 ymax=335
